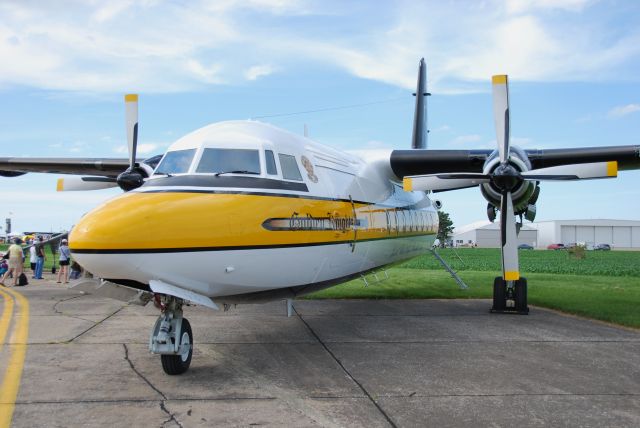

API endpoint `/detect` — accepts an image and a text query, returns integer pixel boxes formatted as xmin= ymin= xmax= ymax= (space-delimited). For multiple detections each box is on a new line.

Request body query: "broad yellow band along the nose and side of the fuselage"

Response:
xmin=69 ymin=192 xmax=437 ymax=251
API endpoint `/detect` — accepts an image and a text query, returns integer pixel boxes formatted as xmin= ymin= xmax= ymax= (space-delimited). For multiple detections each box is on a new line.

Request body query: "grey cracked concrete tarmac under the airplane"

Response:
xmin=0 ymin=280 xmax=640 ymax=427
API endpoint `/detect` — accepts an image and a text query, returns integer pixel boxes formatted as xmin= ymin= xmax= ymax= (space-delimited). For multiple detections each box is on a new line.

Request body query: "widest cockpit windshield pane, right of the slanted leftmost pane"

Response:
xmin=196 ymin=149 xmax=260 ymax=174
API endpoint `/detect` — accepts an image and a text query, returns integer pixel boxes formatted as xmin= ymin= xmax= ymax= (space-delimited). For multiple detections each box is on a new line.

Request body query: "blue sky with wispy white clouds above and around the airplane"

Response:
xmin=0 ymin=0 xmax=640 ymax=233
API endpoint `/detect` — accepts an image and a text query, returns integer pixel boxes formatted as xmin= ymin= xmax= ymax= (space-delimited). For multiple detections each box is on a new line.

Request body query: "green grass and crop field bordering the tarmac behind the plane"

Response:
xmin=309 ymin=248 xmax=640 ymax=328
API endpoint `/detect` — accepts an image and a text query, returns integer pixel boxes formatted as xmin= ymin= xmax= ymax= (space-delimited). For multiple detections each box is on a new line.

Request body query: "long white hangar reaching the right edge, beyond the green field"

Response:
xmin=531 ymin=219 xmax=640 ymax=250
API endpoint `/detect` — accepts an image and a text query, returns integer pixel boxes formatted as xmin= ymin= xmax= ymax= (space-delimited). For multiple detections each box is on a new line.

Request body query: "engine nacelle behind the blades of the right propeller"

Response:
xmin=480 ymin=146 xmax=540 ymax=216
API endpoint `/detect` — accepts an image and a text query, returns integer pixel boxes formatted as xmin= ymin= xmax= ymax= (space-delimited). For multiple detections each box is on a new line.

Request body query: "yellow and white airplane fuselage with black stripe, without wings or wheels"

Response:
xmin=70 ymin=121 xmax=438 ymax=302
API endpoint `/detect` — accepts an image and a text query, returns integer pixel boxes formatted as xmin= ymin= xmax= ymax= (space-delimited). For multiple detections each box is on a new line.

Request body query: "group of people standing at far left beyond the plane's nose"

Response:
xmin=0 ymin=236 xmax=82 ymax=287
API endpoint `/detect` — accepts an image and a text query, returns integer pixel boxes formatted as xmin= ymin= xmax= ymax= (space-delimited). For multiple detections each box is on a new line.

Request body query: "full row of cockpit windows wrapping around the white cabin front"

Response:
xmin=155 ymin=148 xmax=302 ymax=181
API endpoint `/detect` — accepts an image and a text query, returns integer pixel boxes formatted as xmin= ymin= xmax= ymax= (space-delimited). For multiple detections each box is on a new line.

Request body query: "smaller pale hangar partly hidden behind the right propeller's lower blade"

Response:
xmin=452 ymin=220 xmax=538 ymax=248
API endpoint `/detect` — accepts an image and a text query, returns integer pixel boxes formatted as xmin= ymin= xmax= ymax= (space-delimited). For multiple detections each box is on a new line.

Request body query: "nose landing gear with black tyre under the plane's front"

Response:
xmin=149 ymin=294 xmax=193 ymax=375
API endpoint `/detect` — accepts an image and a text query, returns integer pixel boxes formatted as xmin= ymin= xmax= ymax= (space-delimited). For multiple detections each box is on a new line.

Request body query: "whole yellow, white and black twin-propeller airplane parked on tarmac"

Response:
xmin=0 ymin=59 xmax=640 ymax=375
